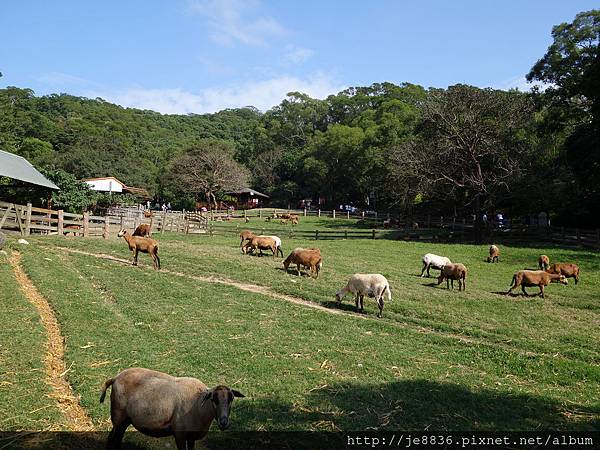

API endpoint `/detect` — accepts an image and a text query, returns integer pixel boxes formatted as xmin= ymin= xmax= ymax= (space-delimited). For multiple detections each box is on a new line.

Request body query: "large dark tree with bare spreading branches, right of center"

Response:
xmin=393 ymin=85 xmax=532 ymax=225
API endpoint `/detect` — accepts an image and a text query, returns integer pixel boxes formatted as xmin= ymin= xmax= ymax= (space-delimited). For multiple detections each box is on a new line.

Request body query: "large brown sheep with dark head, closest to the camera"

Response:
xmin=100 ymin=368 xmax=244 ymax=450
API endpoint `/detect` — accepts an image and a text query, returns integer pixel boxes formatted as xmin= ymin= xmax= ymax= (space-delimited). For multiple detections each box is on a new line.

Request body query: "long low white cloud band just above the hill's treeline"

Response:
xmin=87 ymin=73 xmax=346 ymax=114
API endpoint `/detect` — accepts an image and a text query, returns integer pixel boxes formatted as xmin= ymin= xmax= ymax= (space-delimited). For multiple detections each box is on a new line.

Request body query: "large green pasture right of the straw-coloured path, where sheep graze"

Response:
xmin=0 ymin=225 xmax=600 ymax=440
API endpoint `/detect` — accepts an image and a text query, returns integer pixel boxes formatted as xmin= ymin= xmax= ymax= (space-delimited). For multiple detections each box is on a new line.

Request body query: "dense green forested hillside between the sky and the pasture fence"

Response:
xmin=0 ymin=11 xmax=600 ymax=225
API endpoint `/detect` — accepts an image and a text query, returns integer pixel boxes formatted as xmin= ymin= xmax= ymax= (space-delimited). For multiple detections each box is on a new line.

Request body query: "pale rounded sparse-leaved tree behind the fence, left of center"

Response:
xmin=170 ymin=139 xmax=250 ymax=208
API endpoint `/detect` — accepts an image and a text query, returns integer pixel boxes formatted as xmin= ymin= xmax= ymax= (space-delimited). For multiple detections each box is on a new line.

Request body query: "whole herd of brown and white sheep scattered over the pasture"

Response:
xmin=106 ymin=223 xmax=579 ymax=450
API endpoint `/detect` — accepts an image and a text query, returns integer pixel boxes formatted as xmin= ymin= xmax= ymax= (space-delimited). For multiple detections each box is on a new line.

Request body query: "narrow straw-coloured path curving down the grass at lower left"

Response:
xmin=10 ymin=252 xmax=94 ymax=431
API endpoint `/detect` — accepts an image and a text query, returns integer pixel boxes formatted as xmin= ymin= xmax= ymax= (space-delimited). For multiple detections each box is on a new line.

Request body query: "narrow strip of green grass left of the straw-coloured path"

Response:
xmin=0 ymin=250 xmax=61 ymax=430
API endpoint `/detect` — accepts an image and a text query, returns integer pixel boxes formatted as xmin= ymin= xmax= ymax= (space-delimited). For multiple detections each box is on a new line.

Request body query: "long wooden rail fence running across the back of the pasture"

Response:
xmin=0 ymin=201 xmax=600 ymax=249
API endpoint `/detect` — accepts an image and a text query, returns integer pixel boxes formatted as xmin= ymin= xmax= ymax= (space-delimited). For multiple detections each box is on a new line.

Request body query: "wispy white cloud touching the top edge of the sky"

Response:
xmin=190 ymin=0 xmax=287 ymax=46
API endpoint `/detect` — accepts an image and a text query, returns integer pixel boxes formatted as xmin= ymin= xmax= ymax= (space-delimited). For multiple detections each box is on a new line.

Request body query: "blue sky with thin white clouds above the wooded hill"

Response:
xmin=0 ymin=0 xmax=598 ymax=113
